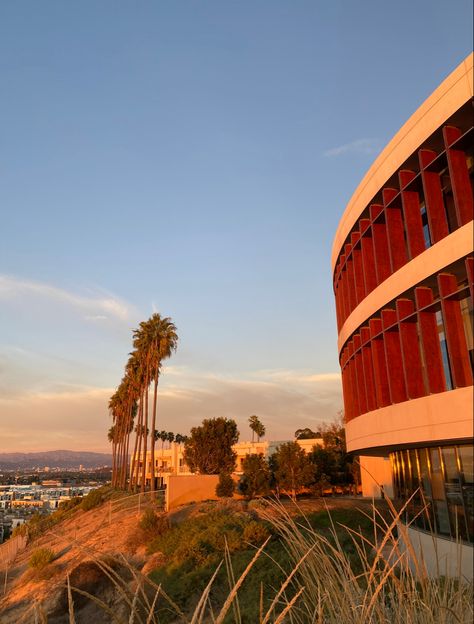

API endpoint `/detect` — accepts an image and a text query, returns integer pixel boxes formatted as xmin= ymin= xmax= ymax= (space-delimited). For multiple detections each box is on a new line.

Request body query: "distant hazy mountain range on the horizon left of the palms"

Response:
xmin=0 ymin=451 xmax=112 ymax=470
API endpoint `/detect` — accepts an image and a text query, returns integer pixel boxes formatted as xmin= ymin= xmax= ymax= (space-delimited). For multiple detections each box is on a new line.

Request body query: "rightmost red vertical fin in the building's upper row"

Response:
xmin=443 ymin=126 xmax=473 ymax=226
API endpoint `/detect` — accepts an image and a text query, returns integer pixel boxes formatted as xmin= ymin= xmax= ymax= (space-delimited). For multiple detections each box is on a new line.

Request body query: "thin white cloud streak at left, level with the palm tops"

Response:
xmin=0 ymin=275 xmax=133 ymax=321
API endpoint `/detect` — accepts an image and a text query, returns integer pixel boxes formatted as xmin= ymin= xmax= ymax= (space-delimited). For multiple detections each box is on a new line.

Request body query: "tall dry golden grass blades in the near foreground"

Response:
xmin=4 ymin=502 xmax=474 ymax=624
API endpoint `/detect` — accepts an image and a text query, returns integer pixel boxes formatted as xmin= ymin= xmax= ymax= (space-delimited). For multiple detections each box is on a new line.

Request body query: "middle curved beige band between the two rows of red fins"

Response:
xmin=338 ymin=221 xmax=473 ymax=351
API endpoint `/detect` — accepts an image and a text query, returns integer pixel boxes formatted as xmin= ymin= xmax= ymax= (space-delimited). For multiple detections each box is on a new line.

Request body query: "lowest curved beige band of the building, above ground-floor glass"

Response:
xmin=346 ymin=386 xmax=474 ymax=451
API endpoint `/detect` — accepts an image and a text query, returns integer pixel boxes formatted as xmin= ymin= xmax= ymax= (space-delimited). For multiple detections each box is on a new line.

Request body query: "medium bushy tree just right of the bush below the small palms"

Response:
xmin=273 ymin=442 xmax=314 ymax=500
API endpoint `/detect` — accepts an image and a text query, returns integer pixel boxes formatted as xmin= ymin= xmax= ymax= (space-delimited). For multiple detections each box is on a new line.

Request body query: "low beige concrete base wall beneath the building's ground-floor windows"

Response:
xmin=408 ymin=528 xmax=474 ymax=581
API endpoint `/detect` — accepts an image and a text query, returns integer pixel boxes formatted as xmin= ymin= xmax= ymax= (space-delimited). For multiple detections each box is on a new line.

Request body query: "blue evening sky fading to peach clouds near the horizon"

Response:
xmin=0 ymin=0 xmax=472 ymax=452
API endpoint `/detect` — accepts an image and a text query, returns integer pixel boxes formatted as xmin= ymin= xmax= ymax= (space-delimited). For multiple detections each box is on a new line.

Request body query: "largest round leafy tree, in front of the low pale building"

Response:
xmin=184 ymin=417 xmax=239 ymax=474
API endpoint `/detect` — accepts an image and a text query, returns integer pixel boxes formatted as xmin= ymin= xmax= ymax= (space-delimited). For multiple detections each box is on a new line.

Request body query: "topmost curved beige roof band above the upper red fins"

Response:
xmin=332 ymin=54 xmax=474 ymax=272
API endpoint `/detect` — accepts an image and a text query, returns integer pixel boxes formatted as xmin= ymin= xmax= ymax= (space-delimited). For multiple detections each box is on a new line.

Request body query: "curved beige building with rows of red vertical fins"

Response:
xmin=332 ymin=55 xmax=474 ymax=576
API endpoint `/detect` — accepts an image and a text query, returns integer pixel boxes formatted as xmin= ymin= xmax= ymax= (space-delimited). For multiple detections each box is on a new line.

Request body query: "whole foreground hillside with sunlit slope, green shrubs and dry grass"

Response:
xmin=0 ymin=489 xmax=466 ymax=624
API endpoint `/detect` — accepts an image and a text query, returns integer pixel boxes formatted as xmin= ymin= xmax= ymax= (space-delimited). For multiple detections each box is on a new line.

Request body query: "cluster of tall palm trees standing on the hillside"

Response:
xmin=108 ymin=313 xmax=178 ymax=491
